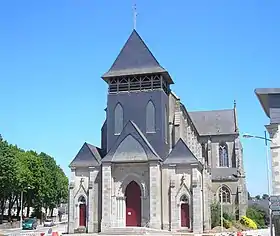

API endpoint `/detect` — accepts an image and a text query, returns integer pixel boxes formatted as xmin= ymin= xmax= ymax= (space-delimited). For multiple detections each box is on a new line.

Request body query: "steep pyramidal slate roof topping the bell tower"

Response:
xmin=102 ymin=30 xmax=173 ymax=84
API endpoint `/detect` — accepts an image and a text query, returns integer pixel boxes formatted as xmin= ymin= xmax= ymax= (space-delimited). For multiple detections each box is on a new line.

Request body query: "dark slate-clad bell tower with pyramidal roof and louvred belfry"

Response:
xmin=102 ymin=29 xmax=173 ymax=159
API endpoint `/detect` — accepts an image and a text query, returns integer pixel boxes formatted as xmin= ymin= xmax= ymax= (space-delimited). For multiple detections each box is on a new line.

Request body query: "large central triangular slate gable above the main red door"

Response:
xmin=102 ymin=121 xmax=161 ymax=162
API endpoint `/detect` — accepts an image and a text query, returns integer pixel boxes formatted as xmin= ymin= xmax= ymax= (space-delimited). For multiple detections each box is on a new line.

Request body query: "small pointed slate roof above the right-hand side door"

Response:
xmin=163 ymin=138 xmax=199 ymax=164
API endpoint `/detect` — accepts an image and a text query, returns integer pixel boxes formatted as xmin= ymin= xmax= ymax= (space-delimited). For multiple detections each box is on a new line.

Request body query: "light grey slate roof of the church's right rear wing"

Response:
xmin=189 ymin=109 xmax=237 ymax=136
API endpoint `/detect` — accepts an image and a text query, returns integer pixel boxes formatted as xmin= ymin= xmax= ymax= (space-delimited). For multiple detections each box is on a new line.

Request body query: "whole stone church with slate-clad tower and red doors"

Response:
xmin=68 ymin=30 xmax=248 ymax=233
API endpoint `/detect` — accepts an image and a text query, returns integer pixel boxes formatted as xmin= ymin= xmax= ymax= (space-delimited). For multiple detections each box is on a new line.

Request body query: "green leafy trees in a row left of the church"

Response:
xmin=0 ymin=136 xmax=68 ymax=220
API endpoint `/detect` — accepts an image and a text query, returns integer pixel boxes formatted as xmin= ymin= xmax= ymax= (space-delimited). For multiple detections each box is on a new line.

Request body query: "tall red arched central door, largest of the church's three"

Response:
xmin=125 ymin=181 xmax=141 ymax=226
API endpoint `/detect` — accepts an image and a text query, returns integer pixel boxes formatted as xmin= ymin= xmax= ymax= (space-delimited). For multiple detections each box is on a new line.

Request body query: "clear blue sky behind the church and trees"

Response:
xmin=0 ymin=0 xmax=280 ymax=195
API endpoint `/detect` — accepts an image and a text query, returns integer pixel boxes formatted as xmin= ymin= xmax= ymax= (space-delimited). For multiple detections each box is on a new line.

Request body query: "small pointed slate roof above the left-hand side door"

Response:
xmin=69 ymin=143 xmax=102 ymax=167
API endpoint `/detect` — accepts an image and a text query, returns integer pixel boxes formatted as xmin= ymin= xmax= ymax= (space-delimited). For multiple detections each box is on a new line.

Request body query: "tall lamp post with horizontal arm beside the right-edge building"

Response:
xmin=243 ymin=131 xmax=273 ymax=236
